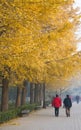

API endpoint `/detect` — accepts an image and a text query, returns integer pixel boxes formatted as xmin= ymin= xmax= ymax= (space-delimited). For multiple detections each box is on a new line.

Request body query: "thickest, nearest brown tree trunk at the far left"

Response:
xmin=1 ymin=78 xmax=9 ymax=111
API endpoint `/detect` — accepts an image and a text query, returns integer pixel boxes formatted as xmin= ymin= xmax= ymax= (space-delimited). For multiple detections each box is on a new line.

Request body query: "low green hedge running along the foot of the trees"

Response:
xmin=0 ymin=104 xmax=37 ymax=123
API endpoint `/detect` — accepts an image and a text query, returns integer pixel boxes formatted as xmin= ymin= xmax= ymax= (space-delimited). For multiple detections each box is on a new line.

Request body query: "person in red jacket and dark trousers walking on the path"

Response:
xmin=52 ymin=94 xmax=61 ymax=116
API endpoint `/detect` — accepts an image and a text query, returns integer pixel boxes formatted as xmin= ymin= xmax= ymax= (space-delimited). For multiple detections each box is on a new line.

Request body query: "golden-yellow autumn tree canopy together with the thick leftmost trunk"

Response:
xmin=0 ymin=0 xmax=80 ymax=111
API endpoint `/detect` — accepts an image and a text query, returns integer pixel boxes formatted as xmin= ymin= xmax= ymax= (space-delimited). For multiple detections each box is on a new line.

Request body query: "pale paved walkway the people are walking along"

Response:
xmin=0 ymin=103 xmax=81 ymax=130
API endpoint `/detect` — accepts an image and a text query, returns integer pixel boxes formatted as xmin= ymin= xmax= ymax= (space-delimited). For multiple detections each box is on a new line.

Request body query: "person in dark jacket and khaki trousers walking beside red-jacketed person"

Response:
xmin=63 ymin=95 xmax=72 ymax=117
